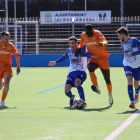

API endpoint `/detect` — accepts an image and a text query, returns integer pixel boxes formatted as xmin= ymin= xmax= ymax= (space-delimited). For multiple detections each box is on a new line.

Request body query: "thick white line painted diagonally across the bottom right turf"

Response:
xmin=104 ymin=108 xmax=140 ymax=140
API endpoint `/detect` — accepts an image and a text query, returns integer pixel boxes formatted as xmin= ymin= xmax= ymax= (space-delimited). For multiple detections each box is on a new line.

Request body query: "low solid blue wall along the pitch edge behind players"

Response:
xmin=12 ymin=53 xmax=124 ymax=67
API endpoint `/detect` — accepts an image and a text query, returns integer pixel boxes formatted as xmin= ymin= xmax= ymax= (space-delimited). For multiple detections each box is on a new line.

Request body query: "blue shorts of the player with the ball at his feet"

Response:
xmin=66 ymin=71 xmax=87 ymax=87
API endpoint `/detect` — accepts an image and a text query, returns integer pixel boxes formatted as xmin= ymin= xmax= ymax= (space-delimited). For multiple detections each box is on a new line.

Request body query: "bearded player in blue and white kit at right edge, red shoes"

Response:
xmin=116 ymin=27 xmax=140 ymax=109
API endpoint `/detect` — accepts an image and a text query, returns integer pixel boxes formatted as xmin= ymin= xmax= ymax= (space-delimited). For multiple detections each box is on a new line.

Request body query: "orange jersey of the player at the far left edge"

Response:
xmin=0 ymin=40 xmax=19 ymax=67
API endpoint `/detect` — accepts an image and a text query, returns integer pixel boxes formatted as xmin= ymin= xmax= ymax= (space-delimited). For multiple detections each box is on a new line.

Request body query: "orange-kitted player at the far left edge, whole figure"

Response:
xmin=0 ymin=31 xmax=20 ymax=106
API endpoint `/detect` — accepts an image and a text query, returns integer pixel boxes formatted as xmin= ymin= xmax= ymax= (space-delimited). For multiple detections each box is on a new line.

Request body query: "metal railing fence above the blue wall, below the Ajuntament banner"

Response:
xmin=0 ymin=16 xmax=140 ymax=54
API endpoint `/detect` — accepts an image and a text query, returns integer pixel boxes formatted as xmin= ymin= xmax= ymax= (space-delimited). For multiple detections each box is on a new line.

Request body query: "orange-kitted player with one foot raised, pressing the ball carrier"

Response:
xmin=76 ymin=24 xmax=113 ymax=105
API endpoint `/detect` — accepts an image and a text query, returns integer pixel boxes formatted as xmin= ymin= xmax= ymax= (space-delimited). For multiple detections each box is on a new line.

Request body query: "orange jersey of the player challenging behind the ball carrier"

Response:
xmin=80 ymin=30 xmax=110 ymax=59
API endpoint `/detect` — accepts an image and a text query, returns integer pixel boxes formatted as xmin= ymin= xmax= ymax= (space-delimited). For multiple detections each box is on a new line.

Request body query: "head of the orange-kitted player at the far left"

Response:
xmin=1 ymin=31 xmax=10 ymax=45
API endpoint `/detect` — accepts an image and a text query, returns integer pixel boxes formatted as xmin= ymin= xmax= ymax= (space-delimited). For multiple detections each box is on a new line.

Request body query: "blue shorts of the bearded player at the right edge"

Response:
xmin=124 ymin=66 xmax=140 ymax=81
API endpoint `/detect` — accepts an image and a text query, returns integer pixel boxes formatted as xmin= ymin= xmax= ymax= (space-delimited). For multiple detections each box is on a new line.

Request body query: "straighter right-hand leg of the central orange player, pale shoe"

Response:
xmin=101 ymin=69 xmax=113 ymax=105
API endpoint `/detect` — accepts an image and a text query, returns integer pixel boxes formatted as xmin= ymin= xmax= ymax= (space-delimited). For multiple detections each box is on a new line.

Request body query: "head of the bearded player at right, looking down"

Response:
xmin=116 ymin=26 xmax=128 ymax=42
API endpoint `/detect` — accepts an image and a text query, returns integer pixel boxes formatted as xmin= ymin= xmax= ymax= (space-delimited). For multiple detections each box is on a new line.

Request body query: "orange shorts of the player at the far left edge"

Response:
xmin=0 ymin=67 xmax=13 ymax=79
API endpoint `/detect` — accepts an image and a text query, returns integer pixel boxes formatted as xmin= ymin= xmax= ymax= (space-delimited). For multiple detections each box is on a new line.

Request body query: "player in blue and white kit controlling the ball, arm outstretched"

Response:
xmin=49 ymin=36 xmax=96 ymax=107
